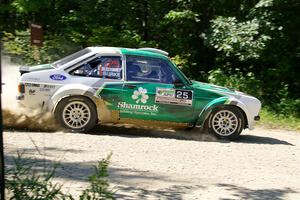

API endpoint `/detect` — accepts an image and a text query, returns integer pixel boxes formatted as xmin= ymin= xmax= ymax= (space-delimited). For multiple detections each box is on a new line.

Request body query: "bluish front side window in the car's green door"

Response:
xmin=126 ymin=56 xmax=178 ymax=84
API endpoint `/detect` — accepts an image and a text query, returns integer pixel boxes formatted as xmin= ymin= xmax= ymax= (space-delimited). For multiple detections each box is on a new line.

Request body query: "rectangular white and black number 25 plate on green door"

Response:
xmin=155 ymin=88 xmax=193 ymax=106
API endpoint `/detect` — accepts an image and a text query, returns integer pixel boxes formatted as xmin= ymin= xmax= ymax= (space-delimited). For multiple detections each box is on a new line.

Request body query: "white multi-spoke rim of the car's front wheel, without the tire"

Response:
xmin=212 ymin=110 xmax=238 ymax=136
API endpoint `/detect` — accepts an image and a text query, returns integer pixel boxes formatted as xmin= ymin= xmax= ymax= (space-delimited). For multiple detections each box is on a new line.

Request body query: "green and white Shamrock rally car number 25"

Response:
xmin=17 ymin=47 xmax=261 ymax=139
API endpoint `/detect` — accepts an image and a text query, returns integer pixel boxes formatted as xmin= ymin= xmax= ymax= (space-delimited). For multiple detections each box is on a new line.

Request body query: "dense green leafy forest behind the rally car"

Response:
xmin=0 ymin=0 xmax=300 ymax=130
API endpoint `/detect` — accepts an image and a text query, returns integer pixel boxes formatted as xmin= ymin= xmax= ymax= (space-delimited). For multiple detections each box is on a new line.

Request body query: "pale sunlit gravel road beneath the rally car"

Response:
xmin=4 ymin=126 xmax=300 ymax=200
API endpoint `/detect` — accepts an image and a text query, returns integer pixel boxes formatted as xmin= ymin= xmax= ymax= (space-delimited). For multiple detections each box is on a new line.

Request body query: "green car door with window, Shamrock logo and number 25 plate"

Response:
xmin=118 ymin=56 xmax=195 ymax=123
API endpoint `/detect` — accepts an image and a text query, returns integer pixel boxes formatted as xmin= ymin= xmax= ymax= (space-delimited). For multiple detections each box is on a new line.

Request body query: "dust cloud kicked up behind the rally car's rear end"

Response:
xmin=1 ymin=56 xmax=58 ymax=131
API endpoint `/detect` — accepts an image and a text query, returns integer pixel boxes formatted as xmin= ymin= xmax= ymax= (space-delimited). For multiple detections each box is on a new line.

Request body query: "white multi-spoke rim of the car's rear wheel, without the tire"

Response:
xmin=62 ymin=101 xmax=91 ymax=129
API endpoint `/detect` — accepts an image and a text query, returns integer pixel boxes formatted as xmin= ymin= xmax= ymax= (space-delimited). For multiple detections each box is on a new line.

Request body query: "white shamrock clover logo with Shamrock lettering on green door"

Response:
xmin=118 ymin=87 xmax=159 ymax=115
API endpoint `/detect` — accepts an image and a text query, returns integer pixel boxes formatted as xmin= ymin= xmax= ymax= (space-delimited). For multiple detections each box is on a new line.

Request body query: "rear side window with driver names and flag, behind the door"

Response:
xmin=70 ymin=56 xmax=122 ymax=79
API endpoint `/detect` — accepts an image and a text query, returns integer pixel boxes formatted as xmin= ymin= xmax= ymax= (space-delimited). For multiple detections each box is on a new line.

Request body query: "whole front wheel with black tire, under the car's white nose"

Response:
xmin=206 ymin=106 xmax=245 ymax=140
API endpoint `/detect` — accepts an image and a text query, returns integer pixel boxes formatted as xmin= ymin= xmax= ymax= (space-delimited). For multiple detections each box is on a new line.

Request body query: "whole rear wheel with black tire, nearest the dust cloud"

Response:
xmin=54 ymin=96 xmax=98 ymax=132
